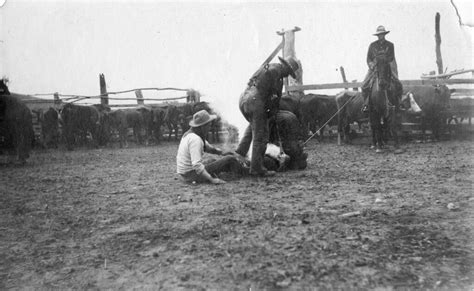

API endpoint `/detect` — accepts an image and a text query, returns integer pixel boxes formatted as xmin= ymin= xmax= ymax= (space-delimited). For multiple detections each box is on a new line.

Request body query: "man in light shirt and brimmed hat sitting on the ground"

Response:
xmin=176 ymin=110 xmax=249 ymax=184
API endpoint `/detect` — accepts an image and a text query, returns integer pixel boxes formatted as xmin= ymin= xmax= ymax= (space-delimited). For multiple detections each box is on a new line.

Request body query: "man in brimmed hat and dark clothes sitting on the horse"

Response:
xmin=362 ymin=25 xmax=398 ymax=112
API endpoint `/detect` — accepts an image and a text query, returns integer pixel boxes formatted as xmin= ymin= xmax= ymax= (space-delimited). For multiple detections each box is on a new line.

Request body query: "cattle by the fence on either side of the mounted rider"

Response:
xmin=280 ymin=85 xmax=451 ymax=142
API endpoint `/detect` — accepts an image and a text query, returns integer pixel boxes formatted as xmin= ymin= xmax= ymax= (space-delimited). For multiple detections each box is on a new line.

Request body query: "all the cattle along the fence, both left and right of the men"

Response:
xmin=0 ymin=85 xmax=462 ymax=162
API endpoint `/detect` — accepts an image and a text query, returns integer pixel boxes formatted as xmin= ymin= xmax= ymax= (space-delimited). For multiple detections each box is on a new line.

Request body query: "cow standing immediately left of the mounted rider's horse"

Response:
xmin=335 ymin=90 xmax=369 ymax=143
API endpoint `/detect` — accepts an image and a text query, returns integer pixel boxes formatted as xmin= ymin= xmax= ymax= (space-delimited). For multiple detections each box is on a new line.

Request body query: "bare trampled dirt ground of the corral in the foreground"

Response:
xmin=0 ymin=138 xmax=474 ymax=290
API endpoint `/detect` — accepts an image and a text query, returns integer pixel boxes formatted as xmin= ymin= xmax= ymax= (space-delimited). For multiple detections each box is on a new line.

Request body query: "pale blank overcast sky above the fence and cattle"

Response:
xmin=0 ymin=0 xmax=474 ymax=130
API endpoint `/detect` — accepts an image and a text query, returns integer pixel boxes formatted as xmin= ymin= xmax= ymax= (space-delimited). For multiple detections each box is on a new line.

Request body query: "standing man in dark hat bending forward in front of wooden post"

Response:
xmin=236 ymin=57 xmax=299 ymax=176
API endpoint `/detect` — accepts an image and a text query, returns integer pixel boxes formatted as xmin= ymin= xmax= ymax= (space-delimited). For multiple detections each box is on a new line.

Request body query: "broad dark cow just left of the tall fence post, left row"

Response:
xmin=60 ymin=103 xmax=100 ymax=150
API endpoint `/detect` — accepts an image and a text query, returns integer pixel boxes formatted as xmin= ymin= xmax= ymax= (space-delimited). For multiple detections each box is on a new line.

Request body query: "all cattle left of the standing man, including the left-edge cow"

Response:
xmin=0 ymin=93 xmax=238 ymax=163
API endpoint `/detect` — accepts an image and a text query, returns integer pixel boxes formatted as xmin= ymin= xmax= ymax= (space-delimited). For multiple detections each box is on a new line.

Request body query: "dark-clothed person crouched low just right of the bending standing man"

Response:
xmin=264 ymin=110 xmax=308 ymax=172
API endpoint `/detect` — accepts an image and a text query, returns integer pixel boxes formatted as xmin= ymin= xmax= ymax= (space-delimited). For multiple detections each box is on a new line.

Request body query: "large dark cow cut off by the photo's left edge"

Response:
xmin=0 ymin=94 xmax=34 ymax=164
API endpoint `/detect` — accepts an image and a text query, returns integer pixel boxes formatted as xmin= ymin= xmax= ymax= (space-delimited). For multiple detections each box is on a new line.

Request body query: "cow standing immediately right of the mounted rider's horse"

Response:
xmin=403 ymin=85 xmax=451 ymax=140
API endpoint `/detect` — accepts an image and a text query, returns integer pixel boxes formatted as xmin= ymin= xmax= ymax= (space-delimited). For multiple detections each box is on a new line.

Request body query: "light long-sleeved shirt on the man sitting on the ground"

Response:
xmin=176 ymin=132 xmax=210 ymax=175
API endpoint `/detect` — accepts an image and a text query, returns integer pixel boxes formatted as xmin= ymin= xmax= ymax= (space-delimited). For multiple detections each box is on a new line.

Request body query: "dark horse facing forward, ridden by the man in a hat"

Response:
xmin=369 ymin=58 xmax=403 ymax=153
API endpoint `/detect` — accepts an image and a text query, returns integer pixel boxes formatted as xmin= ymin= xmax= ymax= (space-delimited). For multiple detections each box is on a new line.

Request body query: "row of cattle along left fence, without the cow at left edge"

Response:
xmin=53 ymin=102 xmax=230 ymax=150
